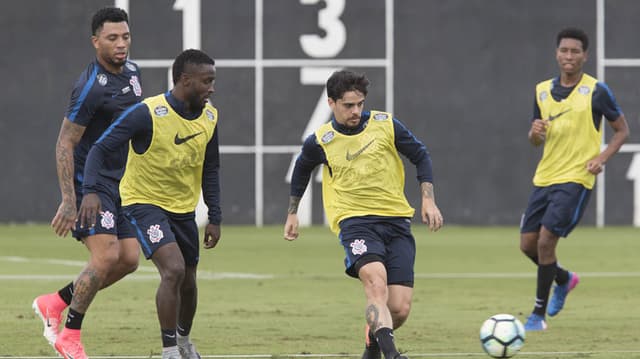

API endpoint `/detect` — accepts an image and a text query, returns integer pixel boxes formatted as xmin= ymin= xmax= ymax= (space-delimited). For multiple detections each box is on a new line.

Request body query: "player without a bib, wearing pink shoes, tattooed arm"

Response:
xmin=33 ymin=7 xmax=142 ymax=359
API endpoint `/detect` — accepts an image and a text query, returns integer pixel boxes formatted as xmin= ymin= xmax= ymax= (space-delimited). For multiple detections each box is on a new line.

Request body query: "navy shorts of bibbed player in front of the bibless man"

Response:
xmin=123 ymin=204 xmax=200 ymax=266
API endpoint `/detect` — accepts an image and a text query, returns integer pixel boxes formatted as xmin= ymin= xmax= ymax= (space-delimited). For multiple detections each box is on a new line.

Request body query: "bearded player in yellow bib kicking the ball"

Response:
xmin=284 ymin=71 xmax=443 ymax=359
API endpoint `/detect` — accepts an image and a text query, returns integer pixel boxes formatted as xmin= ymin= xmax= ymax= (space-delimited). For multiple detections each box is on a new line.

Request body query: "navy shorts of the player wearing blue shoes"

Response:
xmin=520 ymin=182 xmax=591 ymax=237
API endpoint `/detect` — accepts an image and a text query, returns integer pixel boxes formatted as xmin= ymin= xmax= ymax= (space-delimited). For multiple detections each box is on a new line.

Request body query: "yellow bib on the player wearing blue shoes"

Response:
xmin=533 ymin=74 xmax=602 ymax=189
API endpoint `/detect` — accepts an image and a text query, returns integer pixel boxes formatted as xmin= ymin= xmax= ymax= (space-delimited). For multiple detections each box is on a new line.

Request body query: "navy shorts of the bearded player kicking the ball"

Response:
xmin=340 ymin=216 xmax=416 ymax=287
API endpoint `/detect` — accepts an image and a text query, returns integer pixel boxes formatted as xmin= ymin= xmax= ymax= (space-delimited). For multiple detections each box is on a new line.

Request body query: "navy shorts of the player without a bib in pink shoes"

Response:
xmin=71 ymin=182 xmax=136 ymax=240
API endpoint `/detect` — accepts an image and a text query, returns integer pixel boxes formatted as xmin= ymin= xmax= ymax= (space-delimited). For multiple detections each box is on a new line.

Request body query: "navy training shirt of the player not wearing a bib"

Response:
xmin=65 ymin=59 xmax=142 ymax=183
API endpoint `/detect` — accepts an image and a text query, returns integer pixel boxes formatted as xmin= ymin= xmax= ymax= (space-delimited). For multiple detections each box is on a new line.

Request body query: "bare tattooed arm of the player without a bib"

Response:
xmin=51 ymin=117 xmax=85 ymax=236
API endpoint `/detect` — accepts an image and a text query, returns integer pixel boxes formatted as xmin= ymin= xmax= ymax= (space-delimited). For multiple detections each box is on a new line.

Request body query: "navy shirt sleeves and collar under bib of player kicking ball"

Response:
xmin=290 ymin=111 xmax=433 ymax=197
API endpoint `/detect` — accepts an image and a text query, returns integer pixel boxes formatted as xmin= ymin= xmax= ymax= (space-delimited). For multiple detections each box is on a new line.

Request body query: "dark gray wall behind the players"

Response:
xmin=0 ymin=0 xmax=640 ymax=225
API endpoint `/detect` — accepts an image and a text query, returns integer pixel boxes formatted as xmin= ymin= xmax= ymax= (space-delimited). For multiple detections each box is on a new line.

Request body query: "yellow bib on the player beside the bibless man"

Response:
xmin=120 ymin=94 xmax=218 ymax=213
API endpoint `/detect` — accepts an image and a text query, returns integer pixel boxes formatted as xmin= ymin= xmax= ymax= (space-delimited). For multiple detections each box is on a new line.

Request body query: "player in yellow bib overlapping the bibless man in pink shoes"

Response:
xmin=79 ymin=50 xmax=221 ymax=359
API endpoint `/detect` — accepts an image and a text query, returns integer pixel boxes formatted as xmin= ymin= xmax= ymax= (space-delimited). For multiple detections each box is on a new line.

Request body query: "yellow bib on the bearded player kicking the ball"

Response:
xmin=315 ymin=111 xmax=414 ymax=233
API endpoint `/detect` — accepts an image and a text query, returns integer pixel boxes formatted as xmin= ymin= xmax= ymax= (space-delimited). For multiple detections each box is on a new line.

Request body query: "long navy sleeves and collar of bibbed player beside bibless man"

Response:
xmin=82 ymin=91 xmax=222 ymax=224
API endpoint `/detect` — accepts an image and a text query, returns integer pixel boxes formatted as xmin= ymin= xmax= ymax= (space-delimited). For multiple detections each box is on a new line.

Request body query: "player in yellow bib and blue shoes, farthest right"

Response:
xmin=520 ymin=28 xmax=629 ymax=331
